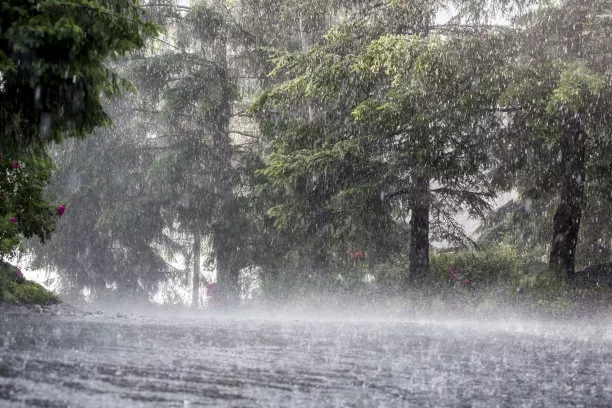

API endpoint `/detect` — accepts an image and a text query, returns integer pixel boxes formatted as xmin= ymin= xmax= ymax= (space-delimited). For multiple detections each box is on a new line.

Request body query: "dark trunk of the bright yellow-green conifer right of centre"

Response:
xmin=409 ymin=177 xmax=429 ymax=286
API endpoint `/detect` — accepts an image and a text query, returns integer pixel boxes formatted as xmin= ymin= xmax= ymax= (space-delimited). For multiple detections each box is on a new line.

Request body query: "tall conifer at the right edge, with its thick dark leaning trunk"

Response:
xmin=498 ymin=0 xmax=612 ymax=281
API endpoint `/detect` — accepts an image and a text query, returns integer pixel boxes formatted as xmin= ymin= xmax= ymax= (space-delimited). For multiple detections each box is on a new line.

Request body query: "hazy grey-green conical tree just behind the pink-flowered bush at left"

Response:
xmin=28 ymin=95 xmax=179 ymax=301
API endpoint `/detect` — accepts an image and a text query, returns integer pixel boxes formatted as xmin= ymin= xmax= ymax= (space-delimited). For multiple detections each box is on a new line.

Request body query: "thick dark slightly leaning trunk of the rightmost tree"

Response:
xmin=549 ymin=118 xmax=587 ymax=282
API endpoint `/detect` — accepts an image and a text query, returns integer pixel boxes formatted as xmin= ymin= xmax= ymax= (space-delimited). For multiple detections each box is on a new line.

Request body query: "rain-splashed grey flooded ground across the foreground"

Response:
xmin=0 ymin=314 xmax=612 ymax=408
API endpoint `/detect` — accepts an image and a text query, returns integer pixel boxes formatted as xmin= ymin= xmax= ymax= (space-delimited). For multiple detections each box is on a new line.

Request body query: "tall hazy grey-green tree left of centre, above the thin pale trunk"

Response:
xmin=124 ymin=1 xmax=306 ymax=306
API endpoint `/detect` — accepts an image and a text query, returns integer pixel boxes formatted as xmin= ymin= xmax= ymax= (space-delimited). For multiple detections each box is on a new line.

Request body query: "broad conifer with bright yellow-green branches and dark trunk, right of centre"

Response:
xmin=255 ymin=2 xmax=505 ymax=284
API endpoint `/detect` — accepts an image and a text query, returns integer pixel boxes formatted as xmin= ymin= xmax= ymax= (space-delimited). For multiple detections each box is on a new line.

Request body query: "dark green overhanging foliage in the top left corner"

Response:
xmin=0 ymin=0 xmax=158 ymax=154
